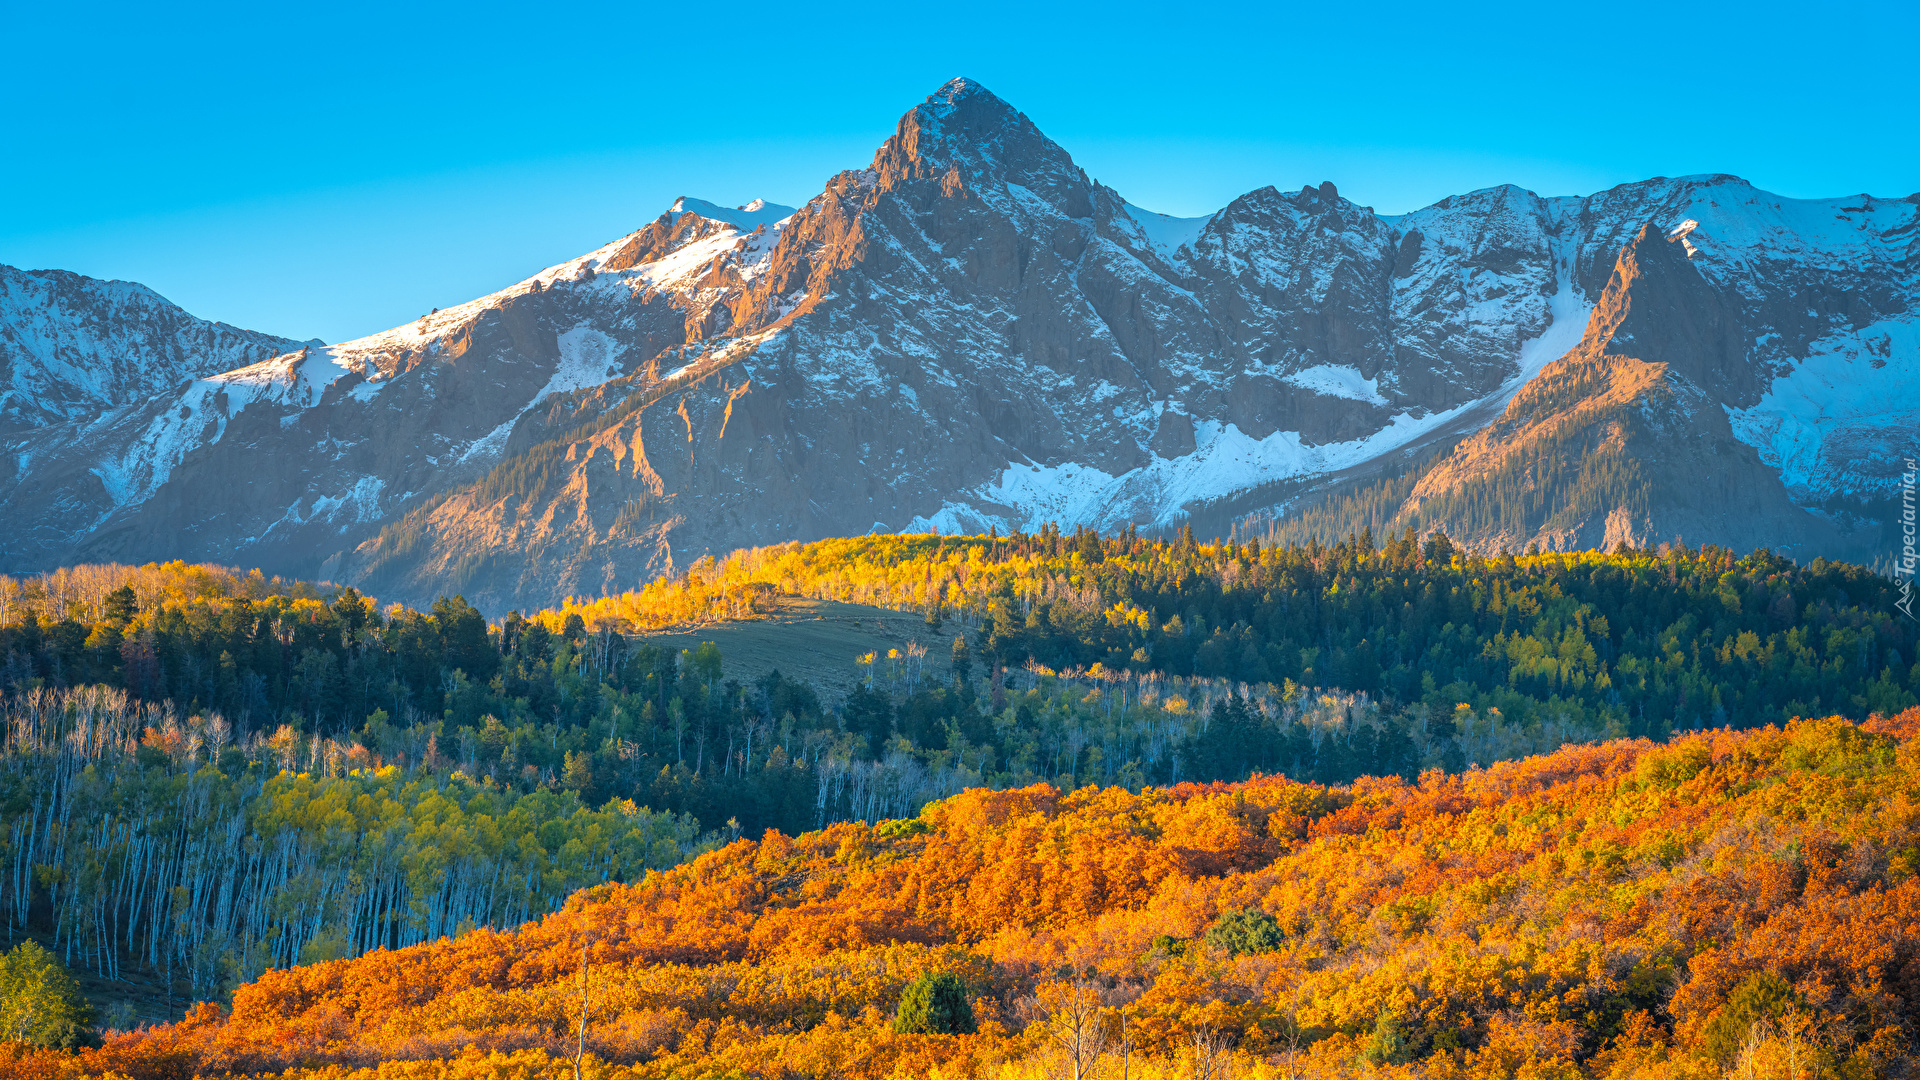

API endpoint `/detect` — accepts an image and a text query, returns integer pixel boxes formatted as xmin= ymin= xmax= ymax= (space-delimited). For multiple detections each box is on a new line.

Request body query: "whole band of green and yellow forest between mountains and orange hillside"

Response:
xmin=0 ymin=528 xmax=1920 ymax=1026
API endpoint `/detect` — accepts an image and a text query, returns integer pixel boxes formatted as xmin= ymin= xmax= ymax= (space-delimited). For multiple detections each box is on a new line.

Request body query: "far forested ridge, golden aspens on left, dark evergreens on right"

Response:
xmin=543 ymin=528 xmax=1920 ymax=737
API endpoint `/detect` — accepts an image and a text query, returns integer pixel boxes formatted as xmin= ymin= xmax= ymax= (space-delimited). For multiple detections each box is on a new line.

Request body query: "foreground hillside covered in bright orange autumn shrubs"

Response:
xmin=10 ymin=711 xmax=1920 ymax=1080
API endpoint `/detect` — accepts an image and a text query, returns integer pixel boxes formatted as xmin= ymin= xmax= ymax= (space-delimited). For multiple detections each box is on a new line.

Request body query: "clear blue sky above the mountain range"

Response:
xmin=0 ymin=0 xmax=1920 ymax=340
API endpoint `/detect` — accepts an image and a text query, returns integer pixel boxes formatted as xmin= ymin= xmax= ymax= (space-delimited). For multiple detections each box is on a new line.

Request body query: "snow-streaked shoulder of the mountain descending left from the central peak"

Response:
xmin=0 ymin=204 xmax=783 ymax=565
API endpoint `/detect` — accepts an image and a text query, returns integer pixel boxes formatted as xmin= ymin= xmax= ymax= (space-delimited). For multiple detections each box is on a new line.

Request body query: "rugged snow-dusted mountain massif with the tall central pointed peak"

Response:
xmin=0 ymin=79 xmax=1920 ymax=611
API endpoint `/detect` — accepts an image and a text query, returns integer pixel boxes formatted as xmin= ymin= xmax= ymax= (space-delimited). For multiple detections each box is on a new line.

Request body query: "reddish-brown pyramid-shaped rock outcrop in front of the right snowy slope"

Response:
xmin=1394 ymin=225 xmax=1845 ymax=550
